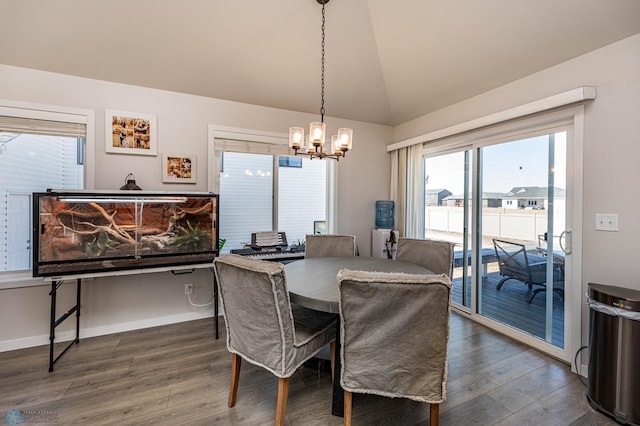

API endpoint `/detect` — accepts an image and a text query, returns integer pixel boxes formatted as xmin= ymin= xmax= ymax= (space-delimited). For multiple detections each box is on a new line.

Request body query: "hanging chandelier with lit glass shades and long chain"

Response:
xmin=289 ymin=0 xmax=353 ymax=160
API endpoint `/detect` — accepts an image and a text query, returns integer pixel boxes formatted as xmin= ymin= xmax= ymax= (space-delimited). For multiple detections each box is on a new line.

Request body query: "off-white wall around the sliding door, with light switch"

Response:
xmin=394 ymin=34 xmax=640 ymax=344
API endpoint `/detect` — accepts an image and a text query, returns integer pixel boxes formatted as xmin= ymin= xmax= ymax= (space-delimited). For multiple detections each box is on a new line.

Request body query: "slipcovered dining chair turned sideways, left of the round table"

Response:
xmin=214 ymin=254 xmax=337 ymax=425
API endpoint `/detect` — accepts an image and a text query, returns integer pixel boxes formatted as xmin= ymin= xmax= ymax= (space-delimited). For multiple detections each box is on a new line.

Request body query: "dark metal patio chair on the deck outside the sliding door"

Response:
xmin=493 ymin=238 xmax=564 ymax=303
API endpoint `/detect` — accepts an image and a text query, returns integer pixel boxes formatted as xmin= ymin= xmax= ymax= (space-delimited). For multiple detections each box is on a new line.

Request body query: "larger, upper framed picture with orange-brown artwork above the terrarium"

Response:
xmin=105 ymin=109 xmax=157 ymax=155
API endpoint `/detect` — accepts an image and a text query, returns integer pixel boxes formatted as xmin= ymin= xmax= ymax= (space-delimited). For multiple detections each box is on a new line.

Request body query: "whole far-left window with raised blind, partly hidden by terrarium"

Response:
xmin=0 ymin=107 xmax=86 ymax=273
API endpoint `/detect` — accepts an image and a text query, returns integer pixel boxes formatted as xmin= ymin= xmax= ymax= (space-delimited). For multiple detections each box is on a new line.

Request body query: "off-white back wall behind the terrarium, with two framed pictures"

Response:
xmin=0 ymin=65 xmax=392 ymax=350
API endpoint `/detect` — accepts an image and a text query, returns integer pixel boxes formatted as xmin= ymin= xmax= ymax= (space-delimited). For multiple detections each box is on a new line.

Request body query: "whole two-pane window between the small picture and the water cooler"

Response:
xmin=213 ymin=134 xmax=329 ymax=253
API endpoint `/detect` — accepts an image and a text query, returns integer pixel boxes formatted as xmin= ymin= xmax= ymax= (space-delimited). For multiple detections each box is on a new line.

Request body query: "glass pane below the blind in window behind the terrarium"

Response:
xmin=0 ymin=134 xmax=84 ymax=271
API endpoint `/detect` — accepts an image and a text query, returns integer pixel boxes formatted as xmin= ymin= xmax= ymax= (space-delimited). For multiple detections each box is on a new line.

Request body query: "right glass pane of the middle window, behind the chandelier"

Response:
xmin=278 ymin=157 xmax=327 ymax=245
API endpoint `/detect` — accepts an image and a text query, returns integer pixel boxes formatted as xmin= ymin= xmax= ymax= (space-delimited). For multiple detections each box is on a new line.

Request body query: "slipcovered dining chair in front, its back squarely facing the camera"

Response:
xmin=338 ymin=269 xmax=451 ymax=426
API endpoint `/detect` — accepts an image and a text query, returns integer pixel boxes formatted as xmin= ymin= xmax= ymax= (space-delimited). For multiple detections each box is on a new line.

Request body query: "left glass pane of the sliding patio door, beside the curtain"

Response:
xmin=424 ymin=151 xmax=471 ymax=307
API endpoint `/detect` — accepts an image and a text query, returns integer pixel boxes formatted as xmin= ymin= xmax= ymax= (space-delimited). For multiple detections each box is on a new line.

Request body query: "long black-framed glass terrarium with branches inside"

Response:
xmin=33 ymin=191 xmax=219 ymax=276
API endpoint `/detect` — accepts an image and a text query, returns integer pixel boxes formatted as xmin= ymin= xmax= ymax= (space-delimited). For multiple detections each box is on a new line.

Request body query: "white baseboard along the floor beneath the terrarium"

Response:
xmin=0 ymin=311 xmax=219 ymax=352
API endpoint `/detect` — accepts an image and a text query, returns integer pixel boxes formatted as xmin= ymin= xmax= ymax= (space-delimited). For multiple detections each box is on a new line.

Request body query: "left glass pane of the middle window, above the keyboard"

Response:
xmin=220 ymin=152 xmax=273 ymax=253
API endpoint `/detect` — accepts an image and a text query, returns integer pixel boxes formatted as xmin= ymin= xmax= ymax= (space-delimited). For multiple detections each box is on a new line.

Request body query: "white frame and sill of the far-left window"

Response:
xmin=0 ymin=99 xmax=95 ymax=290
